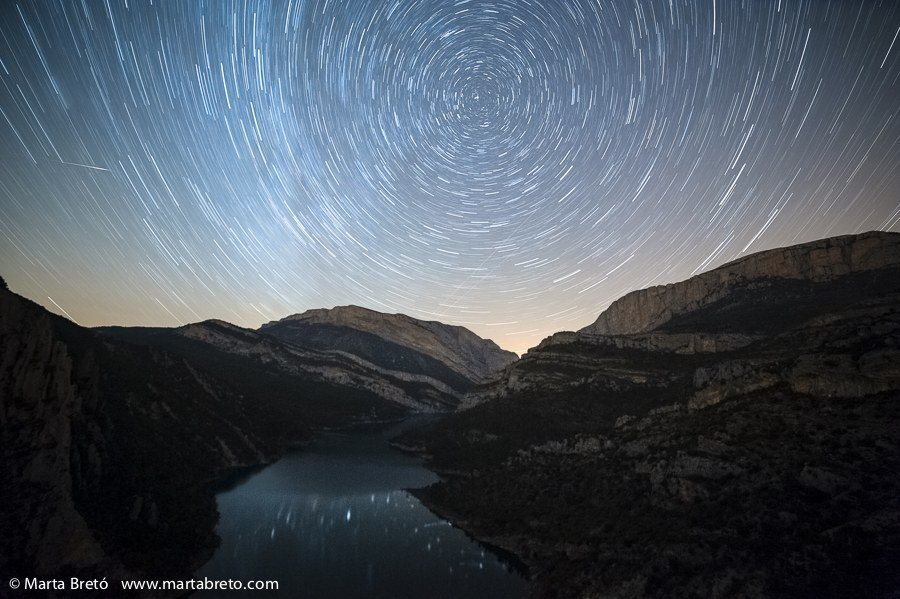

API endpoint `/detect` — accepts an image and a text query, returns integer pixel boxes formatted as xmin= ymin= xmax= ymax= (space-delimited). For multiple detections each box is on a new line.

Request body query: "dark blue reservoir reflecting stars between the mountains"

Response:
xmin=194 ymin=423 xmax=527 ymax=599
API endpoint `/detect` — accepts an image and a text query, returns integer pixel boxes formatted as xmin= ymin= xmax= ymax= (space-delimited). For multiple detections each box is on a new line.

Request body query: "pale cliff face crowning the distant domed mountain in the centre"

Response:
xmin=260 ymin=306 xmax=517 ymax=383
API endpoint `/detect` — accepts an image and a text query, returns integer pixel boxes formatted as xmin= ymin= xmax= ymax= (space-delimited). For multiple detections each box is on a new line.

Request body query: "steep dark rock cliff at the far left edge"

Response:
xmin=0 ymin=290 xmax=106 ymax=585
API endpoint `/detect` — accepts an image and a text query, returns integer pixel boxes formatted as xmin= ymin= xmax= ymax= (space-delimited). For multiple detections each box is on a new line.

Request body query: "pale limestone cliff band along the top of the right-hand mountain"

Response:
xmin=581 ymin=232 xmax=900 ymax=335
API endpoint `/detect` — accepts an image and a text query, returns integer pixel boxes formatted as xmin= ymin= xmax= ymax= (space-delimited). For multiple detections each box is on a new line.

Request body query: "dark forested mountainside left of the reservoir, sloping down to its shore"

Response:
xmin=0 ymin=285 xmax=406 ymax=592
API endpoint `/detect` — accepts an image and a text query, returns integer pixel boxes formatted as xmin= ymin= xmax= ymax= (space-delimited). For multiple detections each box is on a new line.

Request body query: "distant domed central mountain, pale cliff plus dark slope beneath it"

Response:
xmin=259 ymin=306 xmax=517 ymax=390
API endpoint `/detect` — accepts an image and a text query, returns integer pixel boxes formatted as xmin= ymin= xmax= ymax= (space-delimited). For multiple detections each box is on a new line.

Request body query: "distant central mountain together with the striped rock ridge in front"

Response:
xmin=97 ymin=306 xmax=516 ymax=412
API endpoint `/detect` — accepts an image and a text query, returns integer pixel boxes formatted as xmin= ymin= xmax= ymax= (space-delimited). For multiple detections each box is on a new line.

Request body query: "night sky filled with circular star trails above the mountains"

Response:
xmin=0 ymin=0 xmax=900 ymax=352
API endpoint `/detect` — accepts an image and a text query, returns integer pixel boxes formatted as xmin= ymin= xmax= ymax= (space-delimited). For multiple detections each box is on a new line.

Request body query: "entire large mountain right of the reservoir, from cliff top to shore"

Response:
xmin=399 ymin=232 xmax=900 ymax=597
